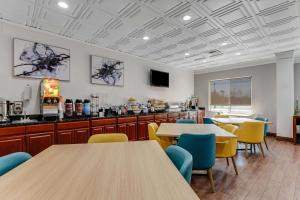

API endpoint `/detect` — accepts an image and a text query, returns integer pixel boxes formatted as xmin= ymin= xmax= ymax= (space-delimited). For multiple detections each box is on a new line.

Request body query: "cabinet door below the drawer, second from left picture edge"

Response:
xmin=26 ymin=132 xmax=54 ymax=156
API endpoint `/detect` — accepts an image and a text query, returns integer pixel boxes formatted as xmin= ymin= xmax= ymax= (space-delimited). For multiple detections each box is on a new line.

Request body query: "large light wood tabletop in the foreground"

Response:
xmin=0 ymin=141 xmax=199 ymax=200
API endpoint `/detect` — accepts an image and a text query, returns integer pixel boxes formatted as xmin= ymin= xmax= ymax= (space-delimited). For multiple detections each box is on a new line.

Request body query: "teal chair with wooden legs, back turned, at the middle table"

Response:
xmin=178 ymin=133 xmax=216 ymax=192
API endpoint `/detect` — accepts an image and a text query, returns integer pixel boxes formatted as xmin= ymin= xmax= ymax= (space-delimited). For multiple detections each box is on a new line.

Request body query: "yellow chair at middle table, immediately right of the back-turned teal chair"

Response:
xmin=216 ymin=124 xmax=238 ymax=175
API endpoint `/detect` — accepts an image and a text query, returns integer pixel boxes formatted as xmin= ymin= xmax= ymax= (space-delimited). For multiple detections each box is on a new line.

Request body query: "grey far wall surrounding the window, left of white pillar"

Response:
xmin=195 ymin=64 xmax=276 ymax=132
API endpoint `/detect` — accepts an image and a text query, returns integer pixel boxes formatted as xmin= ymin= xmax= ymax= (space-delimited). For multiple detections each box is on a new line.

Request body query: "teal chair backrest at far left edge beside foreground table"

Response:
xmin=0 ymin=152 xmax=31 ymax=176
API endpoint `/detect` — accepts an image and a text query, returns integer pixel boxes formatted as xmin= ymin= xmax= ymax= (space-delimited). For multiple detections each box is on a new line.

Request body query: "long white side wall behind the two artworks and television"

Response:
xmin=0 ymin=23 xmax=194 ymax=114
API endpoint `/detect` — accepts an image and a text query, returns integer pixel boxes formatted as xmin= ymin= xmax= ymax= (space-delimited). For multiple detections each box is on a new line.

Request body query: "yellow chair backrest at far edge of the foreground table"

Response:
xmin=88 ymin=133 xmax=128 ymax=144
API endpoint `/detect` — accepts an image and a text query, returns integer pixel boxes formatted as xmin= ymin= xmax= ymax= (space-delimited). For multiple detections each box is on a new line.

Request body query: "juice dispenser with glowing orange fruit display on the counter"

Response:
xmin=40 ymin=78 xmax=60 ymax=118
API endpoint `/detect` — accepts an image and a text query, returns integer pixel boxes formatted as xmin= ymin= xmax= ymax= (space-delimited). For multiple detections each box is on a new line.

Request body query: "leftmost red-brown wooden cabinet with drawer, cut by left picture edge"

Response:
xmin=0 ymin=126 xmax=26 ymax=156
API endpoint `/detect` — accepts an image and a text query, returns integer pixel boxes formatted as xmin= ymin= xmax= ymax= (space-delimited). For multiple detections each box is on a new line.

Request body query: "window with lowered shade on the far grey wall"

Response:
xmin=209 ymin=77 xmax=252 ymax=113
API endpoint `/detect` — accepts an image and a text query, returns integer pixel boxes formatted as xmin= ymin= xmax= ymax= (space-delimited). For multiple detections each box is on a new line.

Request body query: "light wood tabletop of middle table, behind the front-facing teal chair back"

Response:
xmin=156 ymin=123 xmax=236 ymax=138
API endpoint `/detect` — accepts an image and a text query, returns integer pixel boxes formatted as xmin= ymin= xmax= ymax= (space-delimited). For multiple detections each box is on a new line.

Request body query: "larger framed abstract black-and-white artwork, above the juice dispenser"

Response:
xmin=13 ymin=38 xmax=70 ymax=81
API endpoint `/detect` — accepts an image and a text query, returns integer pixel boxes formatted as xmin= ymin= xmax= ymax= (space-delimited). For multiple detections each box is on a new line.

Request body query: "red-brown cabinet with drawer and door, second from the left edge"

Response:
xmin=26 ymin=124 xmax=54 ymax=156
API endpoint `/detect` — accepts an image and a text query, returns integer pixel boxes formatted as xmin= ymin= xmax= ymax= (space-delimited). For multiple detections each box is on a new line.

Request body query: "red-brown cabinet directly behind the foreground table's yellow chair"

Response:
xmin=91 ymin=118 xmax=117 ymax=135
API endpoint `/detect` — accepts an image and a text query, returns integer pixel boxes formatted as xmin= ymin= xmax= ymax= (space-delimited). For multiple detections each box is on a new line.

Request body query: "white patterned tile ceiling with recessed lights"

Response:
xmin=0 ymin=0 xmax=300 ymax=70
